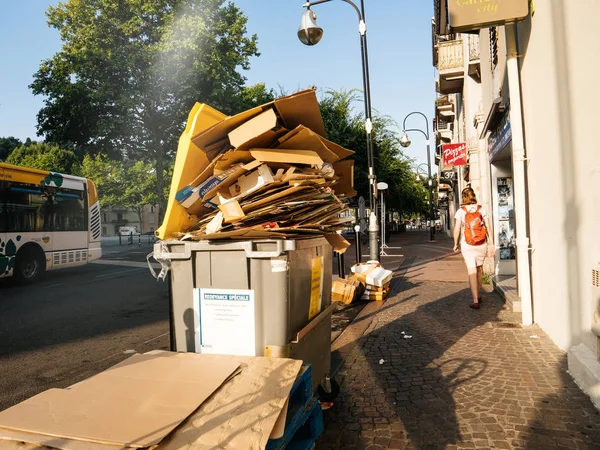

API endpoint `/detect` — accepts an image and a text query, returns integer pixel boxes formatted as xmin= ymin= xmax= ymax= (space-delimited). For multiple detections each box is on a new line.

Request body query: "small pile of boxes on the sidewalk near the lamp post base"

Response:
xmin=331 ymin=261 xmax=393 ymax=304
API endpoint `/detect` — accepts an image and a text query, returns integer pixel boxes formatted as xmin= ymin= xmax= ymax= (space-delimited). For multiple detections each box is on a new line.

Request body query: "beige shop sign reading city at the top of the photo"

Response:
xmin=448 ymin=0 xmax=529 ymax=32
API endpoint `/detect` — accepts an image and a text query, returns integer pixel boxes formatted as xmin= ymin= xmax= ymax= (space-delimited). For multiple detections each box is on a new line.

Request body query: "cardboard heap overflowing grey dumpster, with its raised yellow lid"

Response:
xmin=158 ymin=90 xmax=356 ymax=240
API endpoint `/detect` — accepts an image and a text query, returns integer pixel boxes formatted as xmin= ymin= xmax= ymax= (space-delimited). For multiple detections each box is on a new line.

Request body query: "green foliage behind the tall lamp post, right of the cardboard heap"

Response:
xmin=320 ymin=90 xmax=427 ymax=215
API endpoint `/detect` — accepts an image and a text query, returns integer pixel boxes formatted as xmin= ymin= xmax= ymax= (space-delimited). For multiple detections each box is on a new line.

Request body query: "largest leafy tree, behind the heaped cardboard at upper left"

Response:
xmin=31 ymin=0 xmax=258 ymax=214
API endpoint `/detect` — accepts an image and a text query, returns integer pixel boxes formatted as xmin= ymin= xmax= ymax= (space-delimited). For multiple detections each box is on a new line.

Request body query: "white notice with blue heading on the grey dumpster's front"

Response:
xmin=194 ymin=288 xmax=256 ymax=356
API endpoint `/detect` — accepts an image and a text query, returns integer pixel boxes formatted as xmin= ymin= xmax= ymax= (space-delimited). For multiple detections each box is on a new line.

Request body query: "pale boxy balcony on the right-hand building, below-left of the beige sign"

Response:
xmin=437 ymin=39 xmax=465 ymax=94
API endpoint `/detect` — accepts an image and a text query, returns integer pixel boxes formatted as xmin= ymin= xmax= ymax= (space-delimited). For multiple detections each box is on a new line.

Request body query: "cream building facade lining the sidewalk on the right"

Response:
xmin=433 ymin=0 xmax=600 ymax=405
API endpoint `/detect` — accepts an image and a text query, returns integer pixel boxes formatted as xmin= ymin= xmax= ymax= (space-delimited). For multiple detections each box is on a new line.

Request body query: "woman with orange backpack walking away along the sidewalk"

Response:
xmin=454 ymin=188 xmax=495 ymax=309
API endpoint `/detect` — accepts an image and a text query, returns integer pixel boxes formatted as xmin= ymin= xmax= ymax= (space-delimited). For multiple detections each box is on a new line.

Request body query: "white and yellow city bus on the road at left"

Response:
xmin=0 ymin=163 xmax=102 ymax=283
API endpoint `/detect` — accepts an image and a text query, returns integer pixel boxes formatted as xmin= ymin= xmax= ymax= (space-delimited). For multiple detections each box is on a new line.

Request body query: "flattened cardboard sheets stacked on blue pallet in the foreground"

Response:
xmin=0 ymin=351 xmax=302 ymax=450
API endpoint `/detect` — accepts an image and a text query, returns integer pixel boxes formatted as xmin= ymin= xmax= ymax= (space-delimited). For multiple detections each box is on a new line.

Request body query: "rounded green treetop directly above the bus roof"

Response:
xmin=6 ymin=142 xmax=81 ymax=175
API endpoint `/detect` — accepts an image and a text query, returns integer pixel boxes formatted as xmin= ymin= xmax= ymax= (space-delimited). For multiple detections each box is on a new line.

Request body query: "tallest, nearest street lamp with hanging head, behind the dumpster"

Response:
xmin=298 ymin=0 xmax=379 ymax=260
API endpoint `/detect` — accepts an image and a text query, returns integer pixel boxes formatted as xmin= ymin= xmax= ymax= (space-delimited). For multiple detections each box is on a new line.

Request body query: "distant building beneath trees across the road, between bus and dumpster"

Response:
xmin=101 ymin=205 xmax=160 ymax=237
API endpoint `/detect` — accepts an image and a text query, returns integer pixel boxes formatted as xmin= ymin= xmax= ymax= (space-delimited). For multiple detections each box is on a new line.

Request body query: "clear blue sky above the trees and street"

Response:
xmin=0 ymin=0 xmax=435 ymax=164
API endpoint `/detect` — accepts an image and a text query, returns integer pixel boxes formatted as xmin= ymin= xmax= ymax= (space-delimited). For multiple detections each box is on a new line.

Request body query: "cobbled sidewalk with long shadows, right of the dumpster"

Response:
xmin=317 ymin=232 xmax=600 ymax=449
